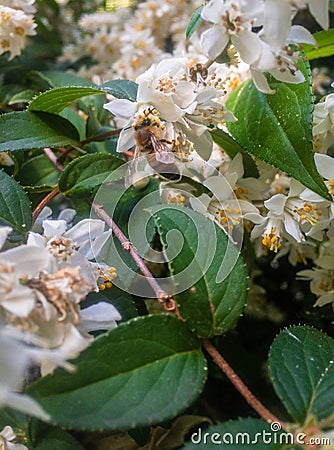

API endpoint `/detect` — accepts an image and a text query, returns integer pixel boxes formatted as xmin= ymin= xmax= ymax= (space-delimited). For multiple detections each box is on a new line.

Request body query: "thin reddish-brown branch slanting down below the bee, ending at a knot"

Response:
xmin=92 ymin=202 xmax=176 ymax=311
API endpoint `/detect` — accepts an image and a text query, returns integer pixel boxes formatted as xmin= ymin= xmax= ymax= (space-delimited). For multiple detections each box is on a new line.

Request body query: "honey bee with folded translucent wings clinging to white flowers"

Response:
xmin=125 ymin=108 xmax=181 ymax=187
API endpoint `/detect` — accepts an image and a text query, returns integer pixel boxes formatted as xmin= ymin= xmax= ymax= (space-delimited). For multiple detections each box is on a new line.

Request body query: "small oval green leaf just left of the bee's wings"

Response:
xmin=59 ymin=153 xmax=123 ymax=197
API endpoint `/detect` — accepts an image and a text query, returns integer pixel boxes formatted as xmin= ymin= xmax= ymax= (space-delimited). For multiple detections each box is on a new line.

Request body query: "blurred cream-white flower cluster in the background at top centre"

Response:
xmin=61 ymin=0 xmax=202 ymax=82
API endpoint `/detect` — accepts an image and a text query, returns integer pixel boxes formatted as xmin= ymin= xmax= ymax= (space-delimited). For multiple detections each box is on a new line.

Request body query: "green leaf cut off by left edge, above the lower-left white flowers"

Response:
xmin=0 ymin=170 xmax=31 ymax=234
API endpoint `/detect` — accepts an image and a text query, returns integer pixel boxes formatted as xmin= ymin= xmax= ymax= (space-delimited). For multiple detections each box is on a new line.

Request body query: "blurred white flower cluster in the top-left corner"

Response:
xmin=0 ymin=0 xmax=36 ymax=59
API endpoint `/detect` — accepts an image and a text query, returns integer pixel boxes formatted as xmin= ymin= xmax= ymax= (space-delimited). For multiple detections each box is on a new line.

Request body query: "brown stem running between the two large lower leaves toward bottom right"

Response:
xmin=202 ymin=339 xmax=285 ymax=428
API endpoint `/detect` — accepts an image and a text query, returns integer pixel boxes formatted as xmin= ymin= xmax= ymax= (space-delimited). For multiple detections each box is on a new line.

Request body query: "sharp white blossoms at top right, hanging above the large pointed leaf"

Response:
xmin=201 ymin=0 xmax=315 ymax=94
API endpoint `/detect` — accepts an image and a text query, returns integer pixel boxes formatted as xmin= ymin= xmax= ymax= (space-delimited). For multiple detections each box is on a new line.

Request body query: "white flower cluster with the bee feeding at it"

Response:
xmin=104 ymin=58 xmax=235 ymax=160
